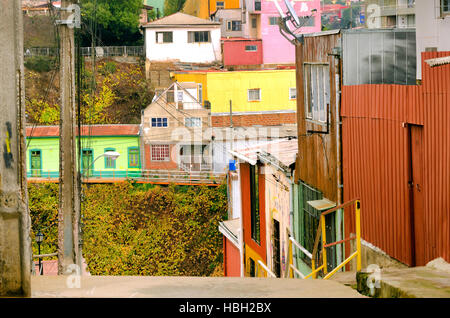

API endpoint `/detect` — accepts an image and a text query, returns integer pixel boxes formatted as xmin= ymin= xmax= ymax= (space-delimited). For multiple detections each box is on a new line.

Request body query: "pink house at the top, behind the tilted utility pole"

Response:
xmin=246 ymin=0 xmax=321 ymax=64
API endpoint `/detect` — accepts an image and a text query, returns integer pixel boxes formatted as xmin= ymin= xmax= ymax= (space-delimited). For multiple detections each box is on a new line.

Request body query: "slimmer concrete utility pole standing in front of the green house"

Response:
xmin=58 ymin=0 xmax=81 ymax=275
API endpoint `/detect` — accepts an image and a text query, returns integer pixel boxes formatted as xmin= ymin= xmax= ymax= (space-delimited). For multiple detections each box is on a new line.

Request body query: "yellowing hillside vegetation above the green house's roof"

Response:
xmin=25 ymin=57 xmax=154 ymax=125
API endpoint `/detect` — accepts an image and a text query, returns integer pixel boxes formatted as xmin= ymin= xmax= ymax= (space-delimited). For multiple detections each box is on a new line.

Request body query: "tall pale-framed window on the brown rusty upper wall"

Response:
xmin=303 ymin=64 xmax=330 ymax=122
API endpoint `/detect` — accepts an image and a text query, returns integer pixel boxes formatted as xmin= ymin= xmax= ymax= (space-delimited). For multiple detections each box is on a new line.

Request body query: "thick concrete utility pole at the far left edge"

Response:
xmin=0 ymin=0 xmax=32 ymax=297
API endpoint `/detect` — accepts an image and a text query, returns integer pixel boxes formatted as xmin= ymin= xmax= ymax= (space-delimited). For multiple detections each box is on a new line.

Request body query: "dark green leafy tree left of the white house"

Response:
xmin=81 ymin=0 xmax=143 ymax=46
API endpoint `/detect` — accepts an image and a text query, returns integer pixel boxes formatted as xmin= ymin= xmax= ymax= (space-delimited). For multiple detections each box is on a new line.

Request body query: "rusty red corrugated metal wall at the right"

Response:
xmin=341 ymin=53 xmax=450 ymax=265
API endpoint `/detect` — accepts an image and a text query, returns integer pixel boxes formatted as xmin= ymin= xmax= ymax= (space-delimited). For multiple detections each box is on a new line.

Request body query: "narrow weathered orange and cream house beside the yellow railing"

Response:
xmin=223 ymin=139 xmax=297 ymax=277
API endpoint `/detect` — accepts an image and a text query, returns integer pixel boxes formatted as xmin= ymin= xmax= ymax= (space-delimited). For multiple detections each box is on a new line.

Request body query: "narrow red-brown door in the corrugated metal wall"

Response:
xmin=409 ymin=125 xmax=426 ymax=266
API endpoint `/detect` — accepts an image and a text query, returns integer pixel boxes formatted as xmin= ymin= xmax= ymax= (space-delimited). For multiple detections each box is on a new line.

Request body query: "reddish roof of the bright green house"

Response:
xmin=27 ymin=125 xmax=139 ymax=137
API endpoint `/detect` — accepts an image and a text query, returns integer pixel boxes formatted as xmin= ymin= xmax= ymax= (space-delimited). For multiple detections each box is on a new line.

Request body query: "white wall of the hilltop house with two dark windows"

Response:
xmin=145 ymin=27 xmax=222 ymax=63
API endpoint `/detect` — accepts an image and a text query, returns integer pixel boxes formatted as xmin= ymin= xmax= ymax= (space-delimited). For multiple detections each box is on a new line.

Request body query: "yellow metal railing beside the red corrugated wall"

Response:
xmin=289 ymin=199 xmax=361 ymax=279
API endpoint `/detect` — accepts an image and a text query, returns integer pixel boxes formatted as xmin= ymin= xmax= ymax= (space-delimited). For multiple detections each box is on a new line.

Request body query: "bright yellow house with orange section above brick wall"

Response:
xmin=173 ymin=69 xmax=297 ymax=114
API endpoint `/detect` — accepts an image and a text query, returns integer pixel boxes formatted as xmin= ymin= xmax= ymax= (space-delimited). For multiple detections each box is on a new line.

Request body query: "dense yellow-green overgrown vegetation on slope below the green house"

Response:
xmin=29 ymin=183 xmax=227 ymax=276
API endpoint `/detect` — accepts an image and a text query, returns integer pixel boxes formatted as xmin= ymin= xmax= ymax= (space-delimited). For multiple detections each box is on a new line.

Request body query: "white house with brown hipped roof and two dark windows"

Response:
xmin=143 ymin=12 xmax=222 ymax=63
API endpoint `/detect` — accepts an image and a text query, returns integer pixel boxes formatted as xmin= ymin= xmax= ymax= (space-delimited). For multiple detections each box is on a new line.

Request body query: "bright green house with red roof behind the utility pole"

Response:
xmin=26 ymin=125 xmax=141 ymax=178
